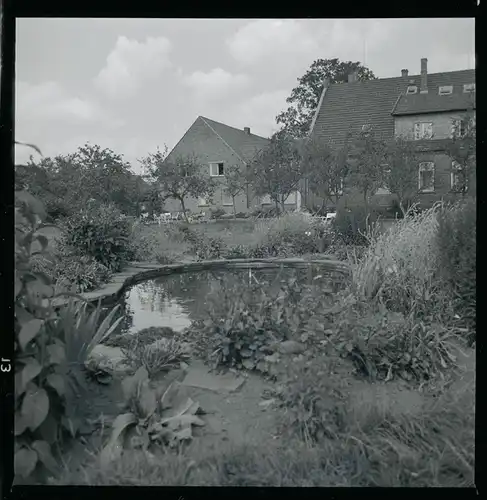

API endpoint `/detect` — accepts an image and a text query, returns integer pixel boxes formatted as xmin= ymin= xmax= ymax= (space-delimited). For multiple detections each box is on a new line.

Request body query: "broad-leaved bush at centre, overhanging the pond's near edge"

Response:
xmin=192 ymin=274 xmax=322 ymax=372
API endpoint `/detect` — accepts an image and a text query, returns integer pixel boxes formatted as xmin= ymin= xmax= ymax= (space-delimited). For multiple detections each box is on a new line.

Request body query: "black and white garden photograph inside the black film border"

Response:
xmin=11 ymin=17 xmax=477 ymax=488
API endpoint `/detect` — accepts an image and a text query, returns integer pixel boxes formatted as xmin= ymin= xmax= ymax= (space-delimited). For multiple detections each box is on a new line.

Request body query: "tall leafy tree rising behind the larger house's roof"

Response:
xmin=276 ymin=58 xmax=375 ymax=138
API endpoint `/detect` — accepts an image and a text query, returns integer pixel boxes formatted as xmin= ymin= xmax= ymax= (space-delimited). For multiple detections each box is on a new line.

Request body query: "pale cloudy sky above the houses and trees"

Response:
xmin=15 ymin=19 xmax=475 ymax=171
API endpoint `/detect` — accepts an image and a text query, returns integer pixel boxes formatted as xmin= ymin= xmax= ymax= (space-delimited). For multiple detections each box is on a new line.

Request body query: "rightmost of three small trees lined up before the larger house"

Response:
xmin=383 ymin=137 xmax=419 ymax=215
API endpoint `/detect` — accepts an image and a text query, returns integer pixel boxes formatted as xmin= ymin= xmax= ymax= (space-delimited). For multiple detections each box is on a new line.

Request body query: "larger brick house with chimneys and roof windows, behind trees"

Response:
xmin=303 ymin=59 xmax=476 ymax=211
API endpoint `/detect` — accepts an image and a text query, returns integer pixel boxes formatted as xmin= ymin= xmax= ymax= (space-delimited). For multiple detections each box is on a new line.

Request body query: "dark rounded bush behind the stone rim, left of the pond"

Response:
xmin=62 ymin=204 xmax=134 ymax=272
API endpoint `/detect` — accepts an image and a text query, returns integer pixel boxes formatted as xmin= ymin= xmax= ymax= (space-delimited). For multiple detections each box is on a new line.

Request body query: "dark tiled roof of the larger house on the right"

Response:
xmin=310 ymin=70 xmax=475 ymax=147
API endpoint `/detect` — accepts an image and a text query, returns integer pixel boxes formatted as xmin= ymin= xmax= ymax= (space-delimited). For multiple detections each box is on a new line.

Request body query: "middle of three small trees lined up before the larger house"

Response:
xmin=348 ymin=129 xmax=387 ymax=214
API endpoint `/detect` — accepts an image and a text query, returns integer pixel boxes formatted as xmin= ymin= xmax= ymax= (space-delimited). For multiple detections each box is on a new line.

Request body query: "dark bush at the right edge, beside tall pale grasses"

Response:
xmin=437 ymin=199 xmax=477 ymax=329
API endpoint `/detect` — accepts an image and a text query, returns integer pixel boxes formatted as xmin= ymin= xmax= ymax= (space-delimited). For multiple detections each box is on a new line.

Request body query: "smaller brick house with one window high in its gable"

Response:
xmin=165 ymin=116 xmax=297 ymax=213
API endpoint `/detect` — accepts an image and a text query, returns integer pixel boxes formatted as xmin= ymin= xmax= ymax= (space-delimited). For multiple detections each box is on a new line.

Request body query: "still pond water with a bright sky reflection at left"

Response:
xmin=111 ymin=266 xmax=344 ymax=333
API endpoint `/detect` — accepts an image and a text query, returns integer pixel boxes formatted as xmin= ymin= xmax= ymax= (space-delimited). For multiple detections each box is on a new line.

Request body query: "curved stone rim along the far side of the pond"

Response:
xmin=53 ymin=258 xmax=351 ymax=308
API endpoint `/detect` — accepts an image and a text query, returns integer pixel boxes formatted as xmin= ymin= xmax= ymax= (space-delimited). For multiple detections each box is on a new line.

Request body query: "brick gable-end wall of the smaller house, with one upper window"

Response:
xmin=164 ymin=120 xmax=256 ymax=213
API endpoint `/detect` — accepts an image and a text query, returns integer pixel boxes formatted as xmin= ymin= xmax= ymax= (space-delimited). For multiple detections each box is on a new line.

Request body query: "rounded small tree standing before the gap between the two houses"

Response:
xmin=247 ymin=134 xmax=303 ymax=212
